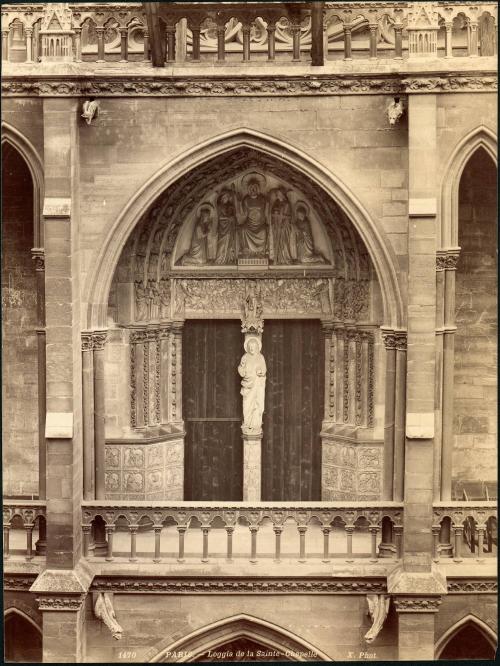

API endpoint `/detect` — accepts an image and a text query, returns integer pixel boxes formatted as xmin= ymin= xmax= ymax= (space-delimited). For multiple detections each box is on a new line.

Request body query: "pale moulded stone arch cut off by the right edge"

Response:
xmin=438 ymin=125 xmax=497 ymax=248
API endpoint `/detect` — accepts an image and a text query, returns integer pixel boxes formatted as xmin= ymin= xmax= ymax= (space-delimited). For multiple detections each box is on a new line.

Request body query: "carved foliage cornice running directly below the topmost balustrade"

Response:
xmin=2 ymin=70 xmax=497 ymax=97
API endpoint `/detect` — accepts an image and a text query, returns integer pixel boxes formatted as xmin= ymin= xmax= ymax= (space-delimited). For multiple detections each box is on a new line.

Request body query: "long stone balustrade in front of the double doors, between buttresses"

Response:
xmin=82 ymin=501 xmax=403 ymax=562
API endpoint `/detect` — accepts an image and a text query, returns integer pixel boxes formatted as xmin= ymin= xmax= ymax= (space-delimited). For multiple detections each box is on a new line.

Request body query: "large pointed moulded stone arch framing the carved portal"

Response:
xmin=85 ymin=128 xmax=404 ymax=329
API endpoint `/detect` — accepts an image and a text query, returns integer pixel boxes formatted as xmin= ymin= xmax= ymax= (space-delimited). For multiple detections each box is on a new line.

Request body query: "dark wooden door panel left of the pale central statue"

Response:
xmin=182 ymin=320 xmax=243 ymax=501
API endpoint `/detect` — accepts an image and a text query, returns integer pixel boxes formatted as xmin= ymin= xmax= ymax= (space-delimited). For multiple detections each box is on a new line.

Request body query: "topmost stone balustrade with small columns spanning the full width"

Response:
xmin=2 ymin=1 xmax=497 ymax=66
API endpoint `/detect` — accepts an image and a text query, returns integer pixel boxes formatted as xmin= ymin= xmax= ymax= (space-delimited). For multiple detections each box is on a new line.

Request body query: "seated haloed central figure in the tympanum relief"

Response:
xmin=238 ymin=174 xmax=268 ymax=257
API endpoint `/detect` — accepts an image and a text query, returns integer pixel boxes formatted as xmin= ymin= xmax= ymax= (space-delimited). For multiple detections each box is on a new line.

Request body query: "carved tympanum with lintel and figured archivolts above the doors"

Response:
xmin=110 ymin=148 xmax=373 ymax=325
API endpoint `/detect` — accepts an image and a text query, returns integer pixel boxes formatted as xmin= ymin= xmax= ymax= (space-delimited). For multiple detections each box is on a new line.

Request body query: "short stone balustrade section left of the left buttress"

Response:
xmin=3 ymin=499 xmax=47 ymax=561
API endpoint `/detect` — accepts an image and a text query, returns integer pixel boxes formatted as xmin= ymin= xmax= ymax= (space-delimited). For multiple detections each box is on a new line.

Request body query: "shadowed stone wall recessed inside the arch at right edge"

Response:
xmin=453 ymin=149 xmax=497 ymax=481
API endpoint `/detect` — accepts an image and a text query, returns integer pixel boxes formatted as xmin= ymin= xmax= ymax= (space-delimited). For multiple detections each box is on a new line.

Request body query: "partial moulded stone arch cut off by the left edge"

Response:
xmin=2 ymin=121 xmax=44 ymax=248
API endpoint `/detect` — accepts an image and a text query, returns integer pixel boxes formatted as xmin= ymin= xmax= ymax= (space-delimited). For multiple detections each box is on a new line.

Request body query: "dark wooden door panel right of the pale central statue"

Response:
xmin=262 ymin=320 xmax=324 ymax=501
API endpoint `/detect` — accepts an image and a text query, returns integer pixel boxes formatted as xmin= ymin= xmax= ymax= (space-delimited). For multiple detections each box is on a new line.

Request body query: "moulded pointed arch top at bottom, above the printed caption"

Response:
xmin=145 ymin=613 xmax=332 ymax=663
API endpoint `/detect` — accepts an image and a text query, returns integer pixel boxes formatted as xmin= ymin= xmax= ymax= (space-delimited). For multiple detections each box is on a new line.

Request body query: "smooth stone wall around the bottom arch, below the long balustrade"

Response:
xmin=86 ymin=594 xmax=397 ymax=663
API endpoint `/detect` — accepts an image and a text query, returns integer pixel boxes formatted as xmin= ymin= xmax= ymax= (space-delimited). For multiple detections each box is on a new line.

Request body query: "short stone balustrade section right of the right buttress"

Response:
xmin=432 ymin=501 xmax=497 ymax=562
